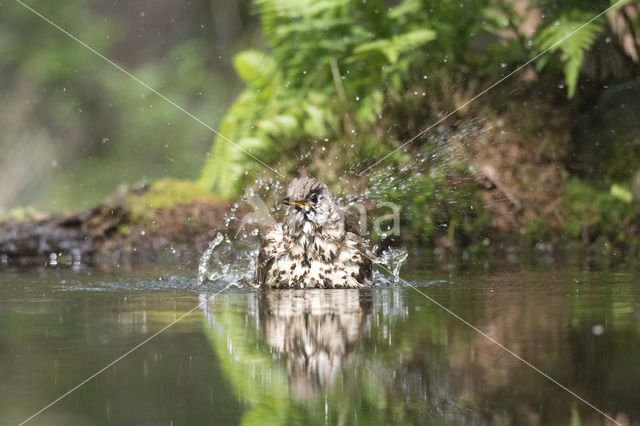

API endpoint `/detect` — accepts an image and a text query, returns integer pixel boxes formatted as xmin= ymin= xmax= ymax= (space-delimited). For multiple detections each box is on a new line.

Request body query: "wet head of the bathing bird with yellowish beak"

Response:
xmin=282 ymin=177 xmax=339 ymax=239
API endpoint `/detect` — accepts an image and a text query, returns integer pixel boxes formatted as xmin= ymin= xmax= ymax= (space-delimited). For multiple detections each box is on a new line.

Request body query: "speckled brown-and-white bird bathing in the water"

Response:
xmin=253 ymin=176 xmax=374 ymax=289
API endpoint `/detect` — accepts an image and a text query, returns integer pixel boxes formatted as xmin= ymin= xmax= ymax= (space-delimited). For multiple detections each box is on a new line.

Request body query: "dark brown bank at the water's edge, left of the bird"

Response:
xmin=0 ymin=202 xmax=238 ymax=268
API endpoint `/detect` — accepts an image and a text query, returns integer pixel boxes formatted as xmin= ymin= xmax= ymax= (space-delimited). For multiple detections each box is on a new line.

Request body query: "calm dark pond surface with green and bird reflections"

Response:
xmin=0 ymin=267 xmax=640 ymax=425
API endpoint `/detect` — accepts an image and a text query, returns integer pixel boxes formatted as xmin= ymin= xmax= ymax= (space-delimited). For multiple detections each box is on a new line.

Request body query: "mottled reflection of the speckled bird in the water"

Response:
xmin=259 ymin=290 xmax=371 ymax=399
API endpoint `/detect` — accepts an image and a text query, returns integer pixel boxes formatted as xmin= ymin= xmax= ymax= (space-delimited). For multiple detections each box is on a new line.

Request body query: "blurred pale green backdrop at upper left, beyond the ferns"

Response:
xmin=0 ymin=0 xmax=252 ymax=209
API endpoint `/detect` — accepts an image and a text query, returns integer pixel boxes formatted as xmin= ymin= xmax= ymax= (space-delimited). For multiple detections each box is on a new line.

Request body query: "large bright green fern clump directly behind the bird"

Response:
xmin=200 ymin=0 xmax=488 ymax=198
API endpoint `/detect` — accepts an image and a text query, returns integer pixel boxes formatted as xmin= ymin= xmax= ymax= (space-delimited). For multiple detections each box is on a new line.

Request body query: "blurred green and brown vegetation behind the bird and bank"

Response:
xmin=0 ymin=0 xmax=640 ymax=256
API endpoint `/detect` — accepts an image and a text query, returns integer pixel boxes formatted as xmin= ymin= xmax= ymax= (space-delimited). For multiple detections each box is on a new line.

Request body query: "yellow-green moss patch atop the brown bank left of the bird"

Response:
xmin=125 ymin=179 xmax=217 ymax=223
